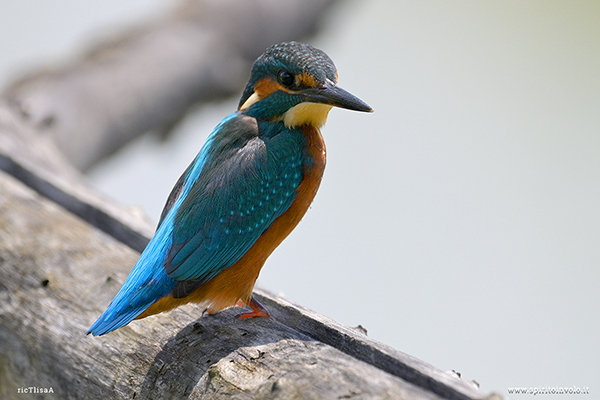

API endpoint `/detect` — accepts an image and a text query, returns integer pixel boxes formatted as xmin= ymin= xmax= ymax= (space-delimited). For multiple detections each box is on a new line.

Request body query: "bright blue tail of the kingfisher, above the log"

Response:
xmin=87 ymin=266 xmax=177 ymax=336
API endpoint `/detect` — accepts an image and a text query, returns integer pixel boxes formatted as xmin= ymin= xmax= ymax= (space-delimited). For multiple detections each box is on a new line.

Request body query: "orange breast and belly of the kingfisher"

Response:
xmin=137 ymin=126 xmax=325 ymax=319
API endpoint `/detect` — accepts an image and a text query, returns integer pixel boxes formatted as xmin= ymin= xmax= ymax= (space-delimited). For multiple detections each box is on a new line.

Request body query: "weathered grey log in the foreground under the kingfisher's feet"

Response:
xmin=0 ymin=100 xmax=498 ymax=399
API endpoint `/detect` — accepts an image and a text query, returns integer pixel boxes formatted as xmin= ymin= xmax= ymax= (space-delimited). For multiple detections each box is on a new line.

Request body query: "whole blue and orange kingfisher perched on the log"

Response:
xmin=87 ymin=42 xmax=373 ymax=336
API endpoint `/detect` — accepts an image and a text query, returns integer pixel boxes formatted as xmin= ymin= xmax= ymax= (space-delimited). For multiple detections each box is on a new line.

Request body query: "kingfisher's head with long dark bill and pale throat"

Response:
xmin=239 ymin=42 xmax=373 ymax=127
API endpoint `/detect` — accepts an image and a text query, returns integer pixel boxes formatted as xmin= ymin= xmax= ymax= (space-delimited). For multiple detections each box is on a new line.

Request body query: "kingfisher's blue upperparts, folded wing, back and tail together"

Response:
xmin=88 ymin=113 xmax=304 ymax=335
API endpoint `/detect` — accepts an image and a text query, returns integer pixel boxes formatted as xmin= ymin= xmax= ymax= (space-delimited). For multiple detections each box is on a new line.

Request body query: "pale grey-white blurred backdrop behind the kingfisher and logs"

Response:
xmin=0 ymin=0 xmax=600 ymax=398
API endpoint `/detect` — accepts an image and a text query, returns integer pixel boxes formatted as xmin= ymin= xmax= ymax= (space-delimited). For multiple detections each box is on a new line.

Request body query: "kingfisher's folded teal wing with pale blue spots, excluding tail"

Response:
xmin=162 ymin=114 xmax=304 ymax=286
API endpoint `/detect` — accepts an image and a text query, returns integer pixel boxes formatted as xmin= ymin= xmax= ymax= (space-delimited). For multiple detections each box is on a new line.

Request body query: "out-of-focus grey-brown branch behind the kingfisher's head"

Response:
xmin=3 ymin=0 xmax=335 ymax=170
